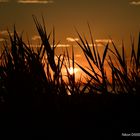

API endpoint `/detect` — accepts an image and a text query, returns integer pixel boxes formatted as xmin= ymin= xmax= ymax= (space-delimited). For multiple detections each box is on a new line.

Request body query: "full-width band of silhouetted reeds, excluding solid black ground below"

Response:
xmin=0 ymin=16 xmax=140 ymax=105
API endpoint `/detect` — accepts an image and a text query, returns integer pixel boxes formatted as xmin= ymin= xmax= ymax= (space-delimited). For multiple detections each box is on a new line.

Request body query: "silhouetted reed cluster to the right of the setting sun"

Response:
xmin=77 ymin=25 xmax=140 ymax=94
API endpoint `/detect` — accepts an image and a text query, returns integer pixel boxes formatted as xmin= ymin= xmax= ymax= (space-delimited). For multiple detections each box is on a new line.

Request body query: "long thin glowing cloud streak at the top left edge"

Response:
xmin=17 ymin=0 xmax=54 ymax=4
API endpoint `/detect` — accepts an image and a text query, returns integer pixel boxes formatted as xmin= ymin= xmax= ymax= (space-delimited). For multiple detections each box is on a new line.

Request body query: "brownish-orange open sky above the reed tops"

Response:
xmin=0 ymin=0 xmax=140 ymax=49
